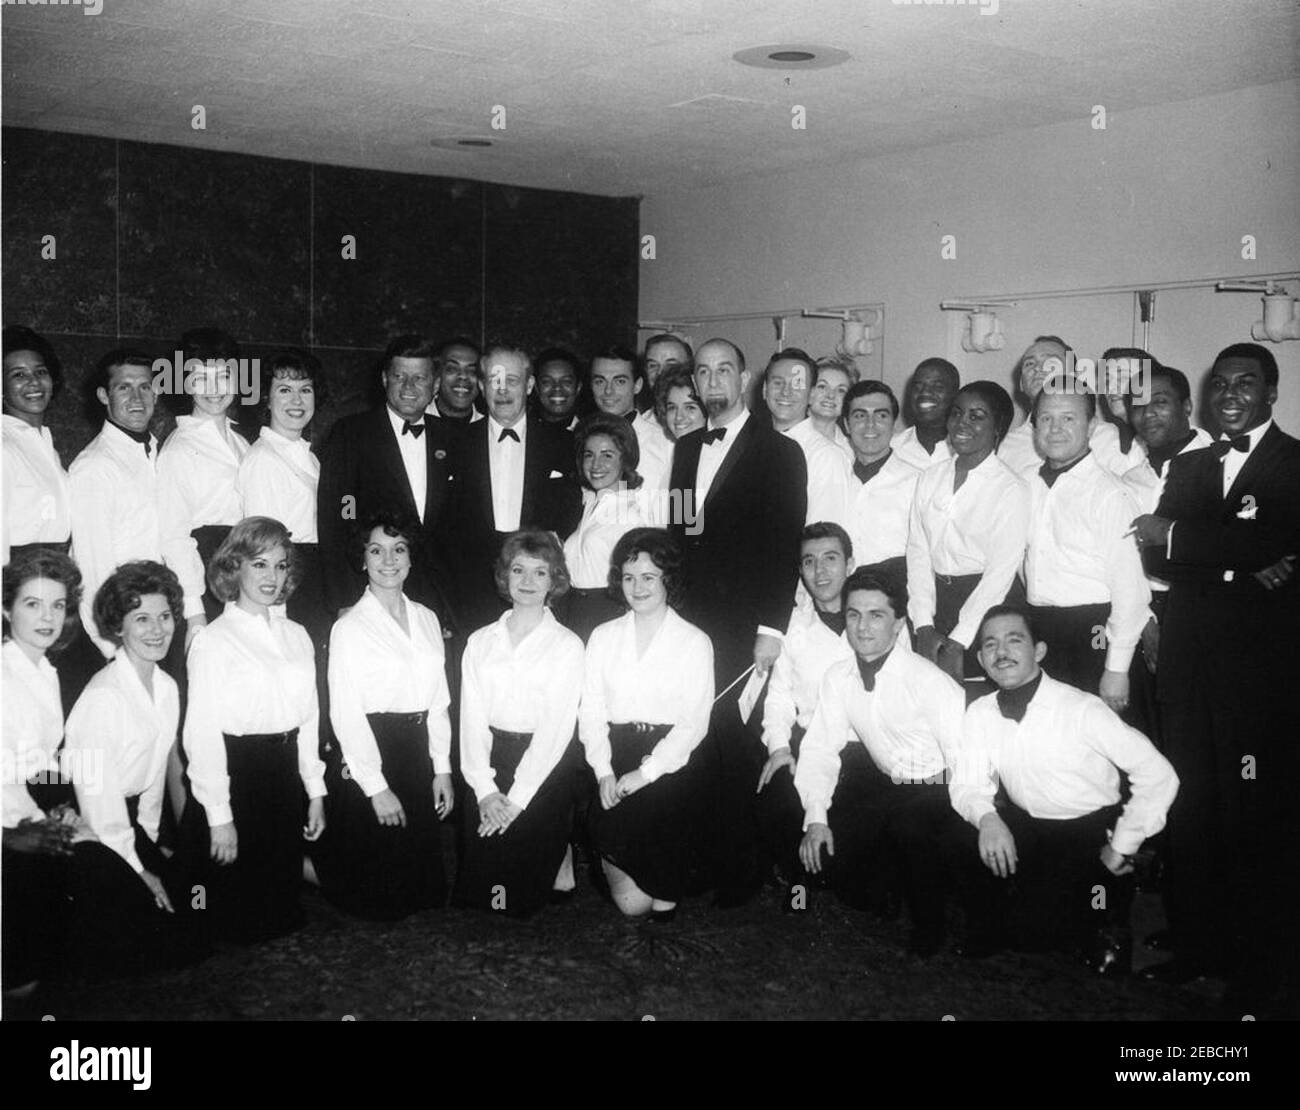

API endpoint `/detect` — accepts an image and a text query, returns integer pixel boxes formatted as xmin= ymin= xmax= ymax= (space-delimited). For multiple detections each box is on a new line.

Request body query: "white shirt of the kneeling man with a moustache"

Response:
xmin=949 ymin=673 xmax=1178 ymax=855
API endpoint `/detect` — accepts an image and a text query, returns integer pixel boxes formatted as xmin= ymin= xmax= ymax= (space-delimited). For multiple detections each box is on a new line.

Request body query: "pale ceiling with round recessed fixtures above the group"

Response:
xmin=0 ymin=0 xmax=1300 ymax=195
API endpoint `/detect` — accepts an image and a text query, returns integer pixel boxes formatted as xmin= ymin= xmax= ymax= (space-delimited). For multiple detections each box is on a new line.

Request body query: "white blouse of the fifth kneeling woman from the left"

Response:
xmin=460 ymin=610 xmax=582 ymax=810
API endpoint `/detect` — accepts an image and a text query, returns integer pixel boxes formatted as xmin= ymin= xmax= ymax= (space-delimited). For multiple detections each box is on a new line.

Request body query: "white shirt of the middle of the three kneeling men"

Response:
xmin=794 ymin=632 xmax=966 ymax=828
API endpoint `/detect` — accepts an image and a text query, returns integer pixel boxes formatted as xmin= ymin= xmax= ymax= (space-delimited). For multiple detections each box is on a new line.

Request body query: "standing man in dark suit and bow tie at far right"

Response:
xmin=1134 ymin=343 xmax=1300 ymax=1016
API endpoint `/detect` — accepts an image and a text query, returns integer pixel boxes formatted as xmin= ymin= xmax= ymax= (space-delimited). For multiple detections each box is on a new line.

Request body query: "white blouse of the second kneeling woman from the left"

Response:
xmin=68 ymin=649 xmax=181 ymax=873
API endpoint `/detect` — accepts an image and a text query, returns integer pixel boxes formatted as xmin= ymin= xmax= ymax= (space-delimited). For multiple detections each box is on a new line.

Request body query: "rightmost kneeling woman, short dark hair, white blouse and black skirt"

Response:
xmin=580 ymin=528 xmax=714 ymax=920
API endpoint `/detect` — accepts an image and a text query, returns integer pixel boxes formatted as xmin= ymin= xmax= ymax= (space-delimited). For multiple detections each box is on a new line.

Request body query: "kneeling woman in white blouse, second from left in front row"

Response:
xmin=64 ymin=561 xmax=202 ymax=970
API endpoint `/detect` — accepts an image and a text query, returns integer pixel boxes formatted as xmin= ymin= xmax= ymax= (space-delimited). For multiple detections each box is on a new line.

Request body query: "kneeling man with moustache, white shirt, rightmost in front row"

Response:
xmin=950 ymin=606 xmax=1178 ymax=975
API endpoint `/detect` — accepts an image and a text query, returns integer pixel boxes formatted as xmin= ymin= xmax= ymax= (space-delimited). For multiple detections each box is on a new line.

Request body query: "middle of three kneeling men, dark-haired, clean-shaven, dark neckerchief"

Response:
xmin=794 ymin=568 xmax=965 ymax=955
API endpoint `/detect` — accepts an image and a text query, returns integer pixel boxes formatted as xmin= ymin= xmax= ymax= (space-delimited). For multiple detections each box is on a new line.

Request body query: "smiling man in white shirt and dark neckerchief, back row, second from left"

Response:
xmin=68 ymin=350 xmax=163 ymax=659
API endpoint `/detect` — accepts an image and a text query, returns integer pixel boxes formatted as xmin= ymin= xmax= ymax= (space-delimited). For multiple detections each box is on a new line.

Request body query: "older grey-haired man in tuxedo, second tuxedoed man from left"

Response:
xmin=446 ymin=346 xmax=582 ymax=632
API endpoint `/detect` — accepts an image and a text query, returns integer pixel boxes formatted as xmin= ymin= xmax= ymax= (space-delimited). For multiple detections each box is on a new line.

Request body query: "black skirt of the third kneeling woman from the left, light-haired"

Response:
xmin=183 ymin=729 xmax=306 ymax=944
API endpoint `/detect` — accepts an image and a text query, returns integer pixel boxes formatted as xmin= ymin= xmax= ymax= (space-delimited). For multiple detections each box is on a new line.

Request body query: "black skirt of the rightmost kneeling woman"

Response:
xmin=589 ymin=723 xmax=693 ymax=902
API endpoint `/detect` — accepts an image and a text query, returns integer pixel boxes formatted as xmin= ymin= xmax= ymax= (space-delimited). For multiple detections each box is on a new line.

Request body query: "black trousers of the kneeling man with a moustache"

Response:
xmin=949 ymin=803 xmax=1134 ymax=950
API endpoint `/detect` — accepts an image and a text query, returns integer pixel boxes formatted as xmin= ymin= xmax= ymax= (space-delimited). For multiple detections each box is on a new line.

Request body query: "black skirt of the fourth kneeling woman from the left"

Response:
xmin=312 ymin=712 xmax=447 ymax=922
